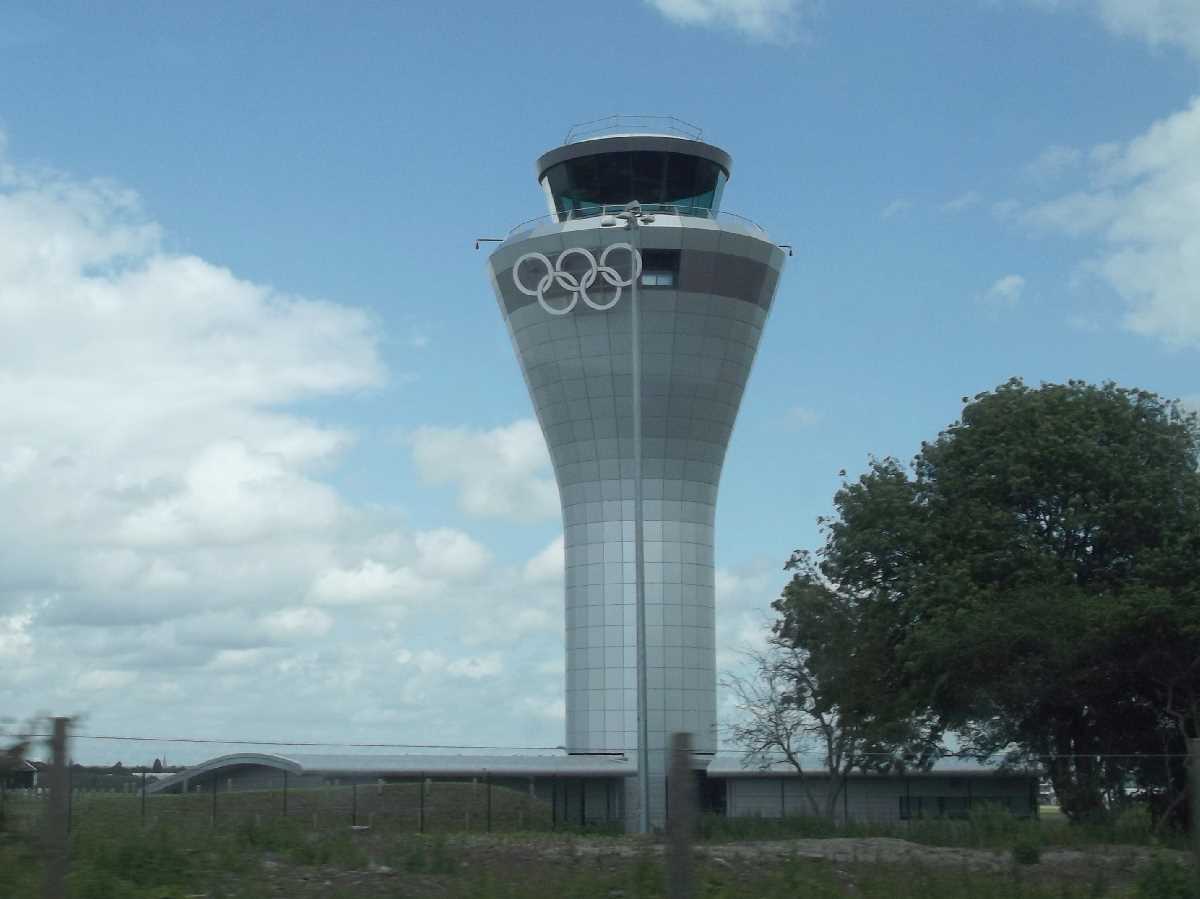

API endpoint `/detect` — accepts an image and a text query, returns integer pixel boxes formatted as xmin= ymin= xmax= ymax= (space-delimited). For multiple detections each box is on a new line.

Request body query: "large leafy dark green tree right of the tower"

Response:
xmin=776 ymin=379 xmax=1200 ymax=819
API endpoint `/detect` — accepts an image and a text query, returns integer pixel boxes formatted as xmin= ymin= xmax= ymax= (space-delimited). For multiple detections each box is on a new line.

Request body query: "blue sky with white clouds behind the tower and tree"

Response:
xmin=0 ymin=0 xmax=1200 ymax=762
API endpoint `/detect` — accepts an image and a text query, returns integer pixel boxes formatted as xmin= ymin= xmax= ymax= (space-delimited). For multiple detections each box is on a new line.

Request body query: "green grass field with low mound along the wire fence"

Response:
xmin=0 ymin=784 xmax=1200 ymax=899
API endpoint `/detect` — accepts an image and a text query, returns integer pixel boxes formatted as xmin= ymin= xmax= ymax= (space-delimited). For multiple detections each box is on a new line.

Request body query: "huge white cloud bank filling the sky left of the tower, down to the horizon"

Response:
xmin=0 ymin=129 xmax=580 ymax=762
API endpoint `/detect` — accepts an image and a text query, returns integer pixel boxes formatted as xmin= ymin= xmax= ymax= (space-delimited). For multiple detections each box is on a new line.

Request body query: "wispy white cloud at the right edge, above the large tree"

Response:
xmin=1024 ymin=97 xmax=1200 ymax=346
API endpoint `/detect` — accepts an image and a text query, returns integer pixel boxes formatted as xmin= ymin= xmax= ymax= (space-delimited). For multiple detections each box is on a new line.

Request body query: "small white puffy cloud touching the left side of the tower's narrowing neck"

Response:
xmin=408 ymin=419 xmax=559 ymax=521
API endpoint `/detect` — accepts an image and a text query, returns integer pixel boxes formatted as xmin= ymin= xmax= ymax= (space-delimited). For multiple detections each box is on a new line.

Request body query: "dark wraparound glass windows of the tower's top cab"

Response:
xmin=542 ymin=150 xmax=727 ymax=218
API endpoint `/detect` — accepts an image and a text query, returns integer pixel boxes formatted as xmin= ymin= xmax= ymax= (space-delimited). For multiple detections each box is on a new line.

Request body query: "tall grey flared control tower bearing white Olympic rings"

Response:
xmin=488 ymin=116 xmax=784 ymax=829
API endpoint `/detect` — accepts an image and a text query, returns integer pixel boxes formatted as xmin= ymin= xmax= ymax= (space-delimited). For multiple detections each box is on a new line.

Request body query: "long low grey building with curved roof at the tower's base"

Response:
xmin=148 ymin=751 xmax=1038 ymax=826
